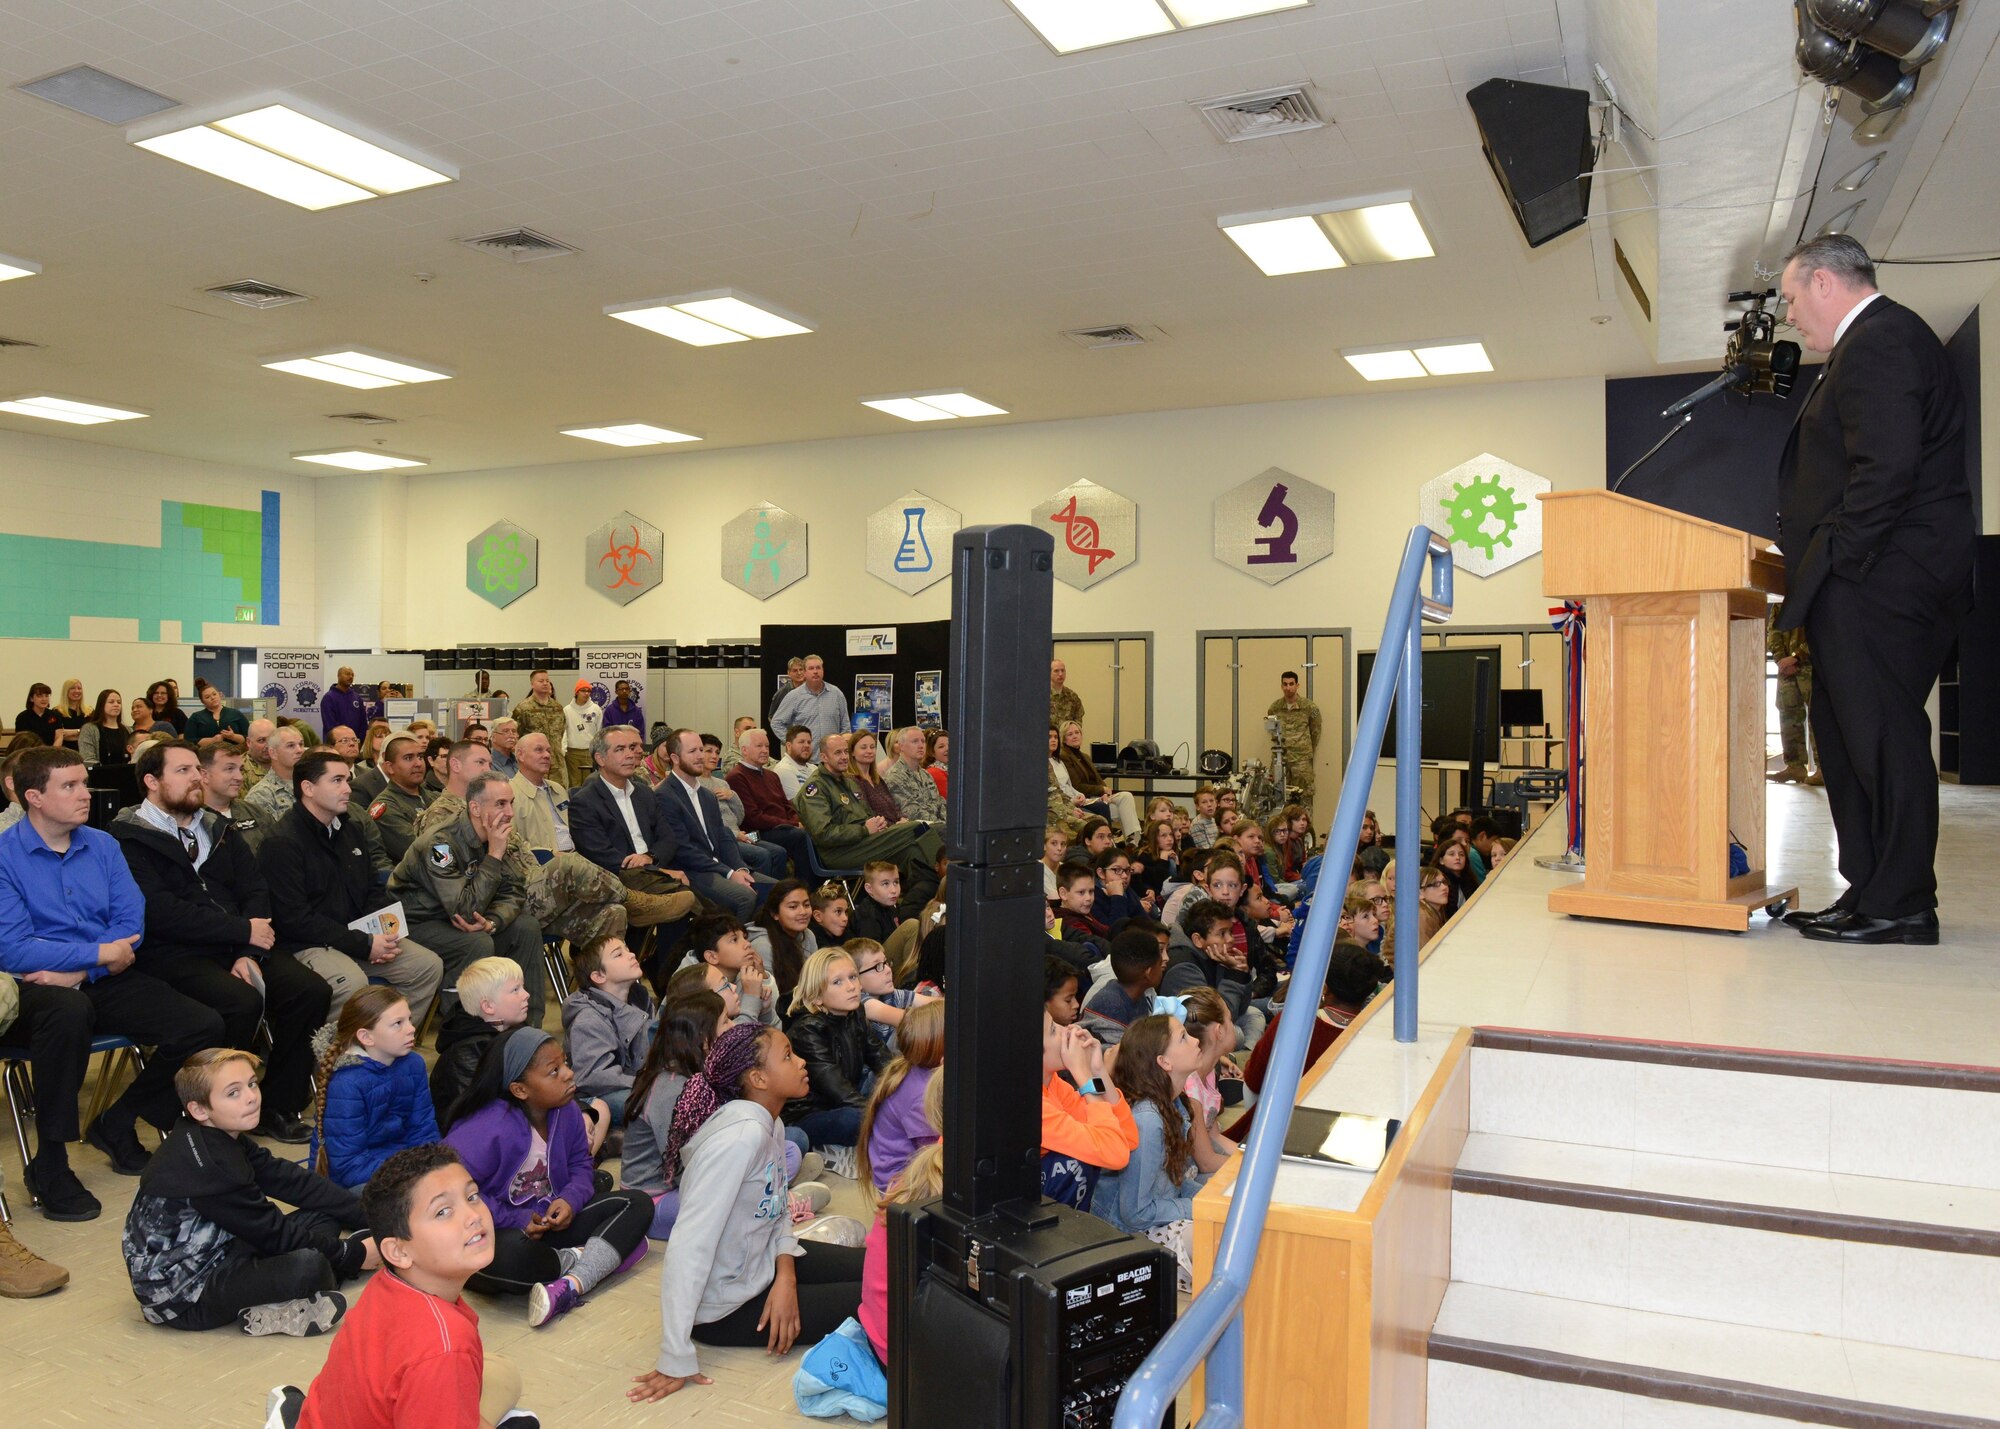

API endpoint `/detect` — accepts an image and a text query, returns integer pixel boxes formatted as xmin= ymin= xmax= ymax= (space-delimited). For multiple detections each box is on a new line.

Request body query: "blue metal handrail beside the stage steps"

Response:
xmin=1112 ymin=526 xmax=1452 ymax=1429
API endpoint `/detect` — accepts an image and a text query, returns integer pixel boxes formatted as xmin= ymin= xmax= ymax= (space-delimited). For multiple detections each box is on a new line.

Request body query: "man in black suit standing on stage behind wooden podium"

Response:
xmin=1778 ymin=234 xmax=1974 ymax=943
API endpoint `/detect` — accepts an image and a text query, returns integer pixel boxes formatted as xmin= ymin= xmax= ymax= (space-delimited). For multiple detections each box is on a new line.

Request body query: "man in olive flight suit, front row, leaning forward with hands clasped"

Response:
xmin=388 ymin=773 xmax=548 ymax=1027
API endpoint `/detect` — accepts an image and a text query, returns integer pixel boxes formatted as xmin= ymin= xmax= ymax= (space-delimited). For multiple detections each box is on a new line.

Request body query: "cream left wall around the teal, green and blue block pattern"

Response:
xmin=0 ymin=430 xmax=320 ymax=723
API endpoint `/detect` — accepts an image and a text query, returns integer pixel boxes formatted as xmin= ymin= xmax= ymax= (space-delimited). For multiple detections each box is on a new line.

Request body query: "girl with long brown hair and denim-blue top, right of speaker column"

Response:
xmin=1090 ymin=1013 xmax=1208 ymax=1293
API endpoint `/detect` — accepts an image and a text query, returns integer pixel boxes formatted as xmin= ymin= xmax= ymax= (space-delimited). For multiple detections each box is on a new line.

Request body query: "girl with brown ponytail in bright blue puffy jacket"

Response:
xmin=312 ymin=987 xmax=440 ymax=1191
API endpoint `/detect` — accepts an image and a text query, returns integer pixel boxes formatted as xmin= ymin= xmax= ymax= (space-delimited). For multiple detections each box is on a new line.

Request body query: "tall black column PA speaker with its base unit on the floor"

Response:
xmin=888 ymin=526 xmax=1176 ymax=1429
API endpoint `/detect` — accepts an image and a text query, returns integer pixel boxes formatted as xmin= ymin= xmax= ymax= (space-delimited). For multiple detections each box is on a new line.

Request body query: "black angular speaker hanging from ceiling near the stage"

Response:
xmin=1466 ymin=80 xmax=1594 ymax=248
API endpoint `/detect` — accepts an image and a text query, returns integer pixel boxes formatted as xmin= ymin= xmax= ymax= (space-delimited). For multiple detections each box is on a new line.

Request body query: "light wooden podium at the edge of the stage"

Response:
xmin=1538 ymin=490 xmax=1798 ymax=933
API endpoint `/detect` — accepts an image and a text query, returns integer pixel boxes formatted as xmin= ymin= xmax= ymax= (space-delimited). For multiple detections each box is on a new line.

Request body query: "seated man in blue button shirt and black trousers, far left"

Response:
xmin=0 ymin=749 xmax=222 ymax=1221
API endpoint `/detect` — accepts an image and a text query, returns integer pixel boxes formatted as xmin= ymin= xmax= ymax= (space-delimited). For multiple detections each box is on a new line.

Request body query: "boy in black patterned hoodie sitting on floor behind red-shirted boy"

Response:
xmin=122 ymin=1047 xmax=380 ymax=1335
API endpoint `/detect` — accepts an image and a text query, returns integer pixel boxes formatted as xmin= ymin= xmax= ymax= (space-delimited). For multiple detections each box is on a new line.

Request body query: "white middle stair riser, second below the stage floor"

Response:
xmin=1452 ymin=1191 xmax=2000 ymax=1359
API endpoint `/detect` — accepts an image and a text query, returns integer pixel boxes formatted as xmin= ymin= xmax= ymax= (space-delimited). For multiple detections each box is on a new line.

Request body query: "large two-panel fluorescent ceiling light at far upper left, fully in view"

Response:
xmin=136 ymin=104 xmax=456 ymax=208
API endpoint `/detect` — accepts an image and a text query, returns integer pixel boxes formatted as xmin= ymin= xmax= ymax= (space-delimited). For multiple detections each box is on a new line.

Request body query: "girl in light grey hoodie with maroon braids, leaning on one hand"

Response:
xmin=626 ymin=1027 xmax=872 ymax=1403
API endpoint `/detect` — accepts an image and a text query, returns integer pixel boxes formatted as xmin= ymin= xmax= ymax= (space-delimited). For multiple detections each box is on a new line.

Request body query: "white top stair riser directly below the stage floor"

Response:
xmin=1472 ymin=1047 xmax=2000 ymax=1189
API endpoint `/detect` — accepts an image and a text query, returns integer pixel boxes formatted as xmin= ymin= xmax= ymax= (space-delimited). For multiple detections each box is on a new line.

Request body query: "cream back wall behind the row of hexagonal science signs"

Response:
xmin=394 ymin=378 xmax=1604 ymax=747
